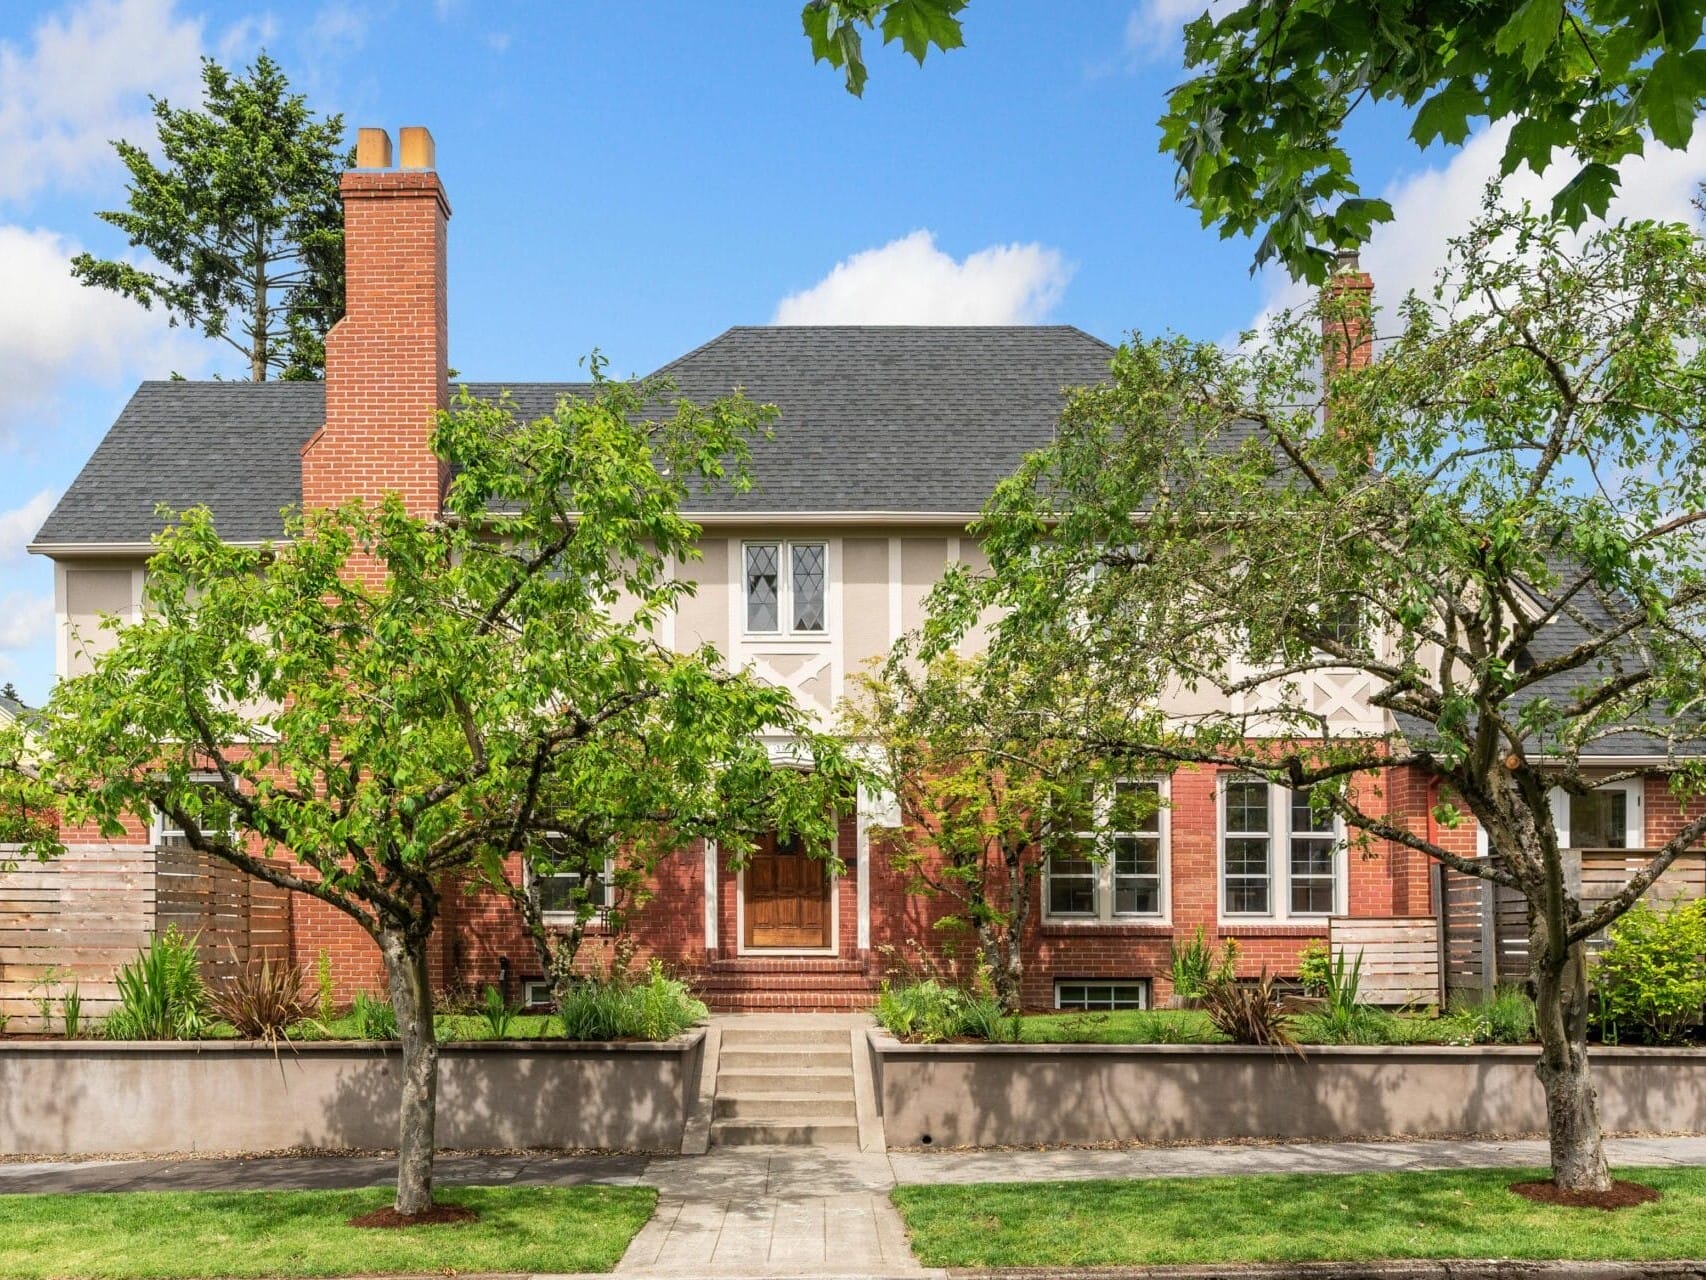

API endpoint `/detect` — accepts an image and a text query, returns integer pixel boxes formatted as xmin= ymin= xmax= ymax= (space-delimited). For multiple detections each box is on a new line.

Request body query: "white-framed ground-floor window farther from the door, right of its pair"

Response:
xmin=1220 ymin=778 xmax=1343 ymax=918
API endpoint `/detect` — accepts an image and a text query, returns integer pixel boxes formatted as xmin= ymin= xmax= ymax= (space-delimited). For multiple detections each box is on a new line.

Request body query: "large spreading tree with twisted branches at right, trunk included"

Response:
xmin=930 ymin=212 xmax=1706 ymax=1188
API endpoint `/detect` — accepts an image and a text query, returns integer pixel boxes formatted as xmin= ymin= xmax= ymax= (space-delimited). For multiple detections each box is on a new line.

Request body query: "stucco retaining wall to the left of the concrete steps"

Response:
xmin=0 ymin=1031 xmax=705 ymax=1155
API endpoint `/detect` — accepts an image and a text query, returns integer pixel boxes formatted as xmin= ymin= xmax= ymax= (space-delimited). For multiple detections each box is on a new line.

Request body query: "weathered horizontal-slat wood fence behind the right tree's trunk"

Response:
xmin=1436 ymin=848 xmax=1706 ymax=995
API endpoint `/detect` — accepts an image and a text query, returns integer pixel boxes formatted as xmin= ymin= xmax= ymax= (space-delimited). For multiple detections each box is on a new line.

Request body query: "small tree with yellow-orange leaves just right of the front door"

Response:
xmin=846 ymin=642 xmax=1112 ymax=1012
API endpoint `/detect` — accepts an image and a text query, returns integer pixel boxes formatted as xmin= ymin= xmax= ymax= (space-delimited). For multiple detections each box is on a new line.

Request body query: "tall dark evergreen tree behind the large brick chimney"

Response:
xmin=72 ymin=53 xmax=353 ymax=382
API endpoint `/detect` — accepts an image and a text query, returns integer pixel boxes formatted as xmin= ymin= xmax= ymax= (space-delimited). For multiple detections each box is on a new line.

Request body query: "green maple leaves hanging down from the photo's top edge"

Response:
xmin=805 ymin=0 xmax=1706 ymax=283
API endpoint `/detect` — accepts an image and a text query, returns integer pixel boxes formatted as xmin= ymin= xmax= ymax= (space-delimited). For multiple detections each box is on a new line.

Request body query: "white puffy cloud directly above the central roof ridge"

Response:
xmin=771 ymin=230 xmax=1073 ymax=324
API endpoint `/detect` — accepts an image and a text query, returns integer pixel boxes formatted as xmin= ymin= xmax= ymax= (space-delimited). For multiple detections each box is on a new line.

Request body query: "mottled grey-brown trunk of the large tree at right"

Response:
xmin=1529 ymin=911 xmax=1610 ymax=1191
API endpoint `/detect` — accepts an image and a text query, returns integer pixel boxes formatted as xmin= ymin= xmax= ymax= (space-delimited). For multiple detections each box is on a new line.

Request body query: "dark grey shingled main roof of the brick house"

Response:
xmin=34 ymin=324 xmax=1114 ymax=551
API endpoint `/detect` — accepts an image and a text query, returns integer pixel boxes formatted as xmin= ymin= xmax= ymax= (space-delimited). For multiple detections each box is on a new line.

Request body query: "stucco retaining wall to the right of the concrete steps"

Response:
xmin=870 ymin=1031 xmax=1706 ymax=1147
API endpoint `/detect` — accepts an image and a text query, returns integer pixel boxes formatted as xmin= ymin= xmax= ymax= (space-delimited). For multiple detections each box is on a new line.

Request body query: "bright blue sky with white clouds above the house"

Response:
xmin=0 ymin=0 xmax=1706 ymax=701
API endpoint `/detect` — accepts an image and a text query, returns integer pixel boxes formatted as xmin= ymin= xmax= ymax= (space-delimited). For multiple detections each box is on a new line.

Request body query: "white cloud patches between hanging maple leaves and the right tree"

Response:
xmin=1252 ymin=123 xmax=1706 ymax=337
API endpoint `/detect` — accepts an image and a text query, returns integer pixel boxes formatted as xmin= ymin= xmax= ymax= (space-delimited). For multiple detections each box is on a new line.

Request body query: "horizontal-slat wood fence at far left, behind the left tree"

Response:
xmin=0 ymin=845 xmax=290 ymax=1031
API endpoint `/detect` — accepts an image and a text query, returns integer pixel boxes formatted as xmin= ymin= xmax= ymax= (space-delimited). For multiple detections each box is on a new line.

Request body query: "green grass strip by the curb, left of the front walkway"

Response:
xmin=0 ymin=1186 xmax=657 ymax=1280
